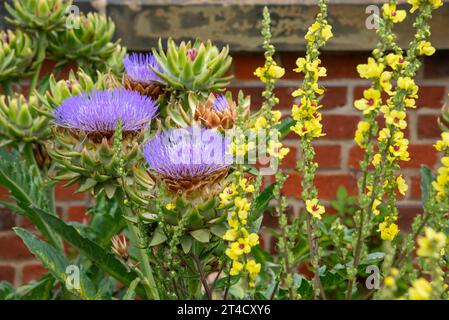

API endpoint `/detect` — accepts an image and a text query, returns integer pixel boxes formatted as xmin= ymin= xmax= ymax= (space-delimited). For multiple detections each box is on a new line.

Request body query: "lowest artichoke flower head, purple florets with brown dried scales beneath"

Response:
xmin=143 ymin=126 xmax=233 ymax=199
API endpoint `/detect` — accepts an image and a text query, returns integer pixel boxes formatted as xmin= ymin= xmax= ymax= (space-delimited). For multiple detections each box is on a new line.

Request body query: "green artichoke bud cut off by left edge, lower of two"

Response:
xmin=0 ymin=95 xmax=51 ymax=145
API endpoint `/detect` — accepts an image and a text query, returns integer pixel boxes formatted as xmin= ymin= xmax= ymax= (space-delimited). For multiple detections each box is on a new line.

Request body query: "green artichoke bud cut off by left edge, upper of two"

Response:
xmin=0 ymin=30 xmax=35 ymax=82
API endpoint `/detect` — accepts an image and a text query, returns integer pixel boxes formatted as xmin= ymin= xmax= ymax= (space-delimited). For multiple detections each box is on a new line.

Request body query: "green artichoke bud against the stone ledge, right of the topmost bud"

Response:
xmin=48 ymin=12 xmax=121 ymax=68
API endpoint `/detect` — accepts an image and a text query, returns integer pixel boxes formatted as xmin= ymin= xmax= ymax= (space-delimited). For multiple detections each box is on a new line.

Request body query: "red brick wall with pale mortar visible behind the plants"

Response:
xmin=0 ymin=52 xmax=449 ymax=285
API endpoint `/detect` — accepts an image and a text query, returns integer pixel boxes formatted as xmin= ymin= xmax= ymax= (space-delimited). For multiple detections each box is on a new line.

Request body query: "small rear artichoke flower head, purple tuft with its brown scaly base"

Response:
xmin=123 ymin=53 xmax=164 ymax=100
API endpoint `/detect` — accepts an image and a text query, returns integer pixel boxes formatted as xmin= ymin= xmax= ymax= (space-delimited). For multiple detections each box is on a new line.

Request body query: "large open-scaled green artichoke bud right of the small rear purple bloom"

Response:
xmin=153 ymin=39 xmax=232 ymax=92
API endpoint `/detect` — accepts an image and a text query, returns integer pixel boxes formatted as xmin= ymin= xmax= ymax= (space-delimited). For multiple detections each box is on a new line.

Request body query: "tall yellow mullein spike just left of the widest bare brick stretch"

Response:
xmin=291 ymin=0 xmax=332 ymax=299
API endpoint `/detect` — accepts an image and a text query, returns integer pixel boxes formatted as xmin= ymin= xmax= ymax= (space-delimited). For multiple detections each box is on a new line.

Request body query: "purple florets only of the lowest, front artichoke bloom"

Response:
xmin=143 ymin=127 xmax=232 ymax=180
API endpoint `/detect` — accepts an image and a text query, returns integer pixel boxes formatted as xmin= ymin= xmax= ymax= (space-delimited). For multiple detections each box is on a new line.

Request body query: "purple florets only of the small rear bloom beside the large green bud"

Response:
xmin=123 ymin=53 xmax=162 ymax=83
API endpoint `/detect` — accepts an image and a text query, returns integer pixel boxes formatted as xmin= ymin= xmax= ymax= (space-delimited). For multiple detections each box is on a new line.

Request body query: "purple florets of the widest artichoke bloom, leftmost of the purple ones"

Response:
xmin=53 ymin=89 xmax=157 ymax=133
